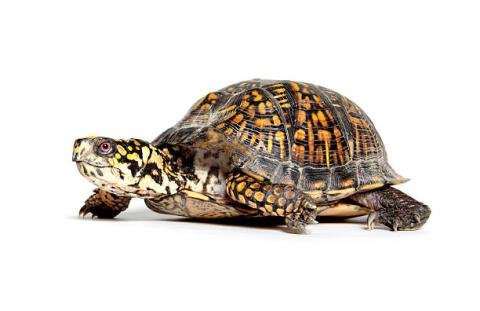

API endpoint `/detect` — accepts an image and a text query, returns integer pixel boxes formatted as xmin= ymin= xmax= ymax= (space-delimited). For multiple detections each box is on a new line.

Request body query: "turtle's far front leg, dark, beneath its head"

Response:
xmin=78 ymin=189 xmax=131 ymax=218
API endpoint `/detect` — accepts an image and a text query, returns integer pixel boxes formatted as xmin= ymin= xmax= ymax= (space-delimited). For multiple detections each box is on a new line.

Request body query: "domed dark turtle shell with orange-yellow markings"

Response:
xmin=153 ymin=79 xmax=406 ymax=200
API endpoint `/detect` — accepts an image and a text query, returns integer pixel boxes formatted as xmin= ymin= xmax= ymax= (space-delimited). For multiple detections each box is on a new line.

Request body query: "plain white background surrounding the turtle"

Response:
xmin=0 ymin=0 xmax=480 ymax=310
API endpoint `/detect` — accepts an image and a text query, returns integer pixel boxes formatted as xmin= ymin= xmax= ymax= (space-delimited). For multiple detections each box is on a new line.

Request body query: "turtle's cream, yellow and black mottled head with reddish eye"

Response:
xmin=72 ymin=137 xmax=183 ymax=198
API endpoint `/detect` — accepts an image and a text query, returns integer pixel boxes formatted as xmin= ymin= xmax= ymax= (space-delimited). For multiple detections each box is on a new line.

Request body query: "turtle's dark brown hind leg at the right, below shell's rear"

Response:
xmin=351 ymin=187 xmax=431 ymax=231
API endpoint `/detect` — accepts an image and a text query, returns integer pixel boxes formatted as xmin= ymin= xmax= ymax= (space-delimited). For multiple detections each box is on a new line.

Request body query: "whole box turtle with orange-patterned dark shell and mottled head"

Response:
xmin=73 ymin=79 xmax=430 ymax=233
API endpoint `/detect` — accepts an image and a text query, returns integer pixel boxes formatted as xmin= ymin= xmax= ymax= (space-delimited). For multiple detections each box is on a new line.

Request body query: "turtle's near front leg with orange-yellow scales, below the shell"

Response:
xmin=226 ymin=171 xmax=317 ymax=233
